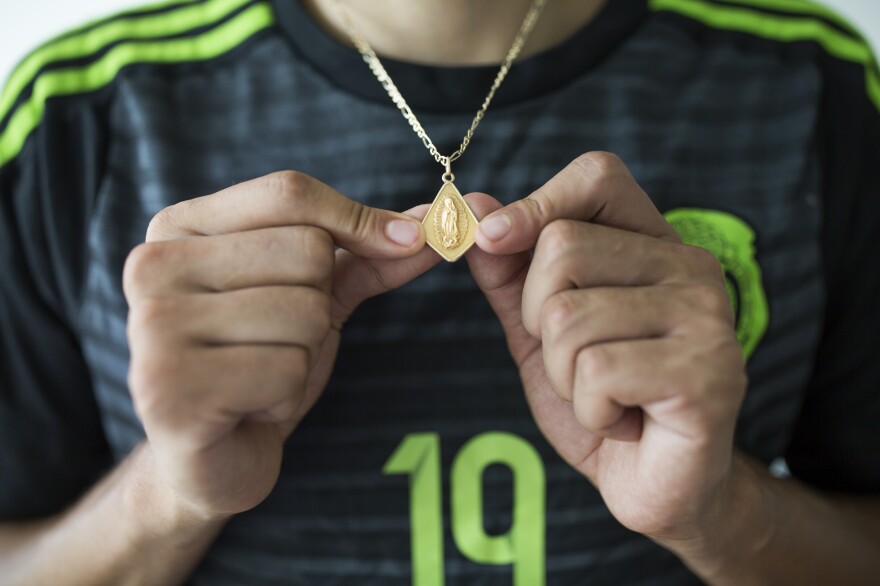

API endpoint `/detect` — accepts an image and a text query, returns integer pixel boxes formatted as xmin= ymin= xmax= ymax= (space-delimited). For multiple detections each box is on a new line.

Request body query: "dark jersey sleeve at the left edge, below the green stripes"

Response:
xmin=0 ymin=70 xmax=110 ymax=522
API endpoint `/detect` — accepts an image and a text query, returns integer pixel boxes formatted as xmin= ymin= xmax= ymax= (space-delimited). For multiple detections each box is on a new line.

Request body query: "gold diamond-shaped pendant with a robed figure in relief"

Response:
xmin=422 ymin=180 xmax=479 ymax=262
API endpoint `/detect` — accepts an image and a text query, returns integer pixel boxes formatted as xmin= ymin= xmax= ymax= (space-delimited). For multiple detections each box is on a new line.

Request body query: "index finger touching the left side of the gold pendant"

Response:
xmin=147 ymin=171 xmax=425 ymax=258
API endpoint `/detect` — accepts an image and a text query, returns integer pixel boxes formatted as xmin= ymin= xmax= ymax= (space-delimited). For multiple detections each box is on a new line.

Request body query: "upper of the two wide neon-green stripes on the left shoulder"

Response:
xmin=0 ymin=0 xmax=258 ymax=129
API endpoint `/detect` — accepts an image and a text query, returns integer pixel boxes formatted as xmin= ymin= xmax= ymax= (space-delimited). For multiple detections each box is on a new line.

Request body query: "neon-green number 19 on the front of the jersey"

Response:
xmin=383 ymin=432 xmax=545 ymax=586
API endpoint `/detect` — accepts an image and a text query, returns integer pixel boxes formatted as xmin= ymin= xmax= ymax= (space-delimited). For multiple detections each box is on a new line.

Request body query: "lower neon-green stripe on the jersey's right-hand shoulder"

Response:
xmin=650 ymin=0 xmax=880 ymax=111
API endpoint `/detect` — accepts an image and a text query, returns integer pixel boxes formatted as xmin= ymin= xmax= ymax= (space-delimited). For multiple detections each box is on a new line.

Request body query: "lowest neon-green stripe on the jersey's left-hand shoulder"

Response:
xmin=0 ymin=2 xmax=275 ymax=167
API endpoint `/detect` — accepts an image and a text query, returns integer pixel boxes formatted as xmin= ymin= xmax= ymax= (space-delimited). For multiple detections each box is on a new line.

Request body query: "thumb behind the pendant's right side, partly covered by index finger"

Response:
xmin=465 ymin=193 xmax=540 ymax=367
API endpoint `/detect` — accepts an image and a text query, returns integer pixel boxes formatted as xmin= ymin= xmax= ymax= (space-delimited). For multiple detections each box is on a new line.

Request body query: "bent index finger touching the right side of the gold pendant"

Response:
xmin=476 ymin=152 xmax=679 ymax=254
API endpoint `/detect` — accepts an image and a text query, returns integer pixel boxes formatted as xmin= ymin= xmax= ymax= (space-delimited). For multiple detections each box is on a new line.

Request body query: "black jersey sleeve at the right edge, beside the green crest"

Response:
xmin=786 ymin=50 xmax=880 ymax=493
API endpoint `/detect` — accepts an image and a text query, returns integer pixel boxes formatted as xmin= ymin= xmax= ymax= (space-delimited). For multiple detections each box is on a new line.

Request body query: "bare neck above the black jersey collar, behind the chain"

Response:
xmin=300 ymin=0 xmax=606 ymax=66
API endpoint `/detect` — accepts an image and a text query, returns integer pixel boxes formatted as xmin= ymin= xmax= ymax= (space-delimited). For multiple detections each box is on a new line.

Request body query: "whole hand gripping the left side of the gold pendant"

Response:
xmin=124 ymin=172 xmax=439 ymax=519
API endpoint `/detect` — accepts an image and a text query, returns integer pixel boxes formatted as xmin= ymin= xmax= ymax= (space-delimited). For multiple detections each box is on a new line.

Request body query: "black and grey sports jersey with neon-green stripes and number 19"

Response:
xmin=0 ymin=0 xmax=880 ymax=586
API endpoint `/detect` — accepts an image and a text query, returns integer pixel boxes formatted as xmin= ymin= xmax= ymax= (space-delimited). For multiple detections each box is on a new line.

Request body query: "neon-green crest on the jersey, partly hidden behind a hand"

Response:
xmin=664 ymin=208 xmax=770 ymax=358
